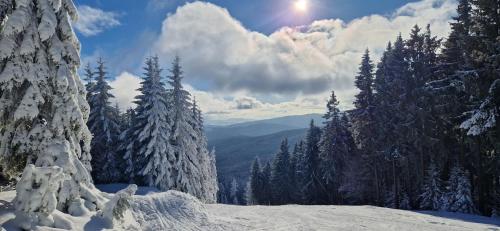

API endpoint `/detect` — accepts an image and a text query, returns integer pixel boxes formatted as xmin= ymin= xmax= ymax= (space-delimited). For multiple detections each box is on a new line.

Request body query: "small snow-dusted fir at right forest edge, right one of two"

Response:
xmin=448 ymin=166 xmax=476 ymax=213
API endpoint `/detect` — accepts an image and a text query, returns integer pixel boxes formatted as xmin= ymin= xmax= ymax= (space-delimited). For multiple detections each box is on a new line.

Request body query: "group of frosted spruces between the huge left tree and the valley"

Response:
xmin=61 ymin=56 xmax=217 ymax=202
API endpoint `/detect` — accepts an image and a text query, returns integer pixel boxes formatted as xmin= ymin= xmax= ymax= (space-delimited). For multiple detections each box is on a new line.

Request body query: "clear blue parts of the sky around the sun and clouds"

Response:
xmin=76 ymin=0 xmax=414 ymax=74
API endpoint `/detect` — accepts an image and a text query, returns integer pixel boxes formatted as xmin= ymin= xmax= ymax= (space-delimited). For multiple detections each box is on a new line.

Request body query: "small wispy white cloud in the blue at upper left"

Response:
xmin=75 ymin=5 xmax=120 ymax=36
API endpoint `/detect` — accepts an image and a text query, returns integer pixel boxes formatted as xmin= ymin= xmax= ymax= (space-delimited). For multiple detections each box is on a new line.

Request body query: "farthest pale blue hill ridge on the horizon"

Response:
xmin=206 ymin=114 xmax=324 ymax=142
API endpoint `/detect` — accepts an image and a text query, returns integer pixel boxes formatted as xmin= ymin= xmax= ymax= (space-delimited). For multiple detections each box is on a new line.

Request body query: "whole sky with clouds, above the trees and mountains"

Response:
xmin=75 ymin=0 xmax=456 ymax=123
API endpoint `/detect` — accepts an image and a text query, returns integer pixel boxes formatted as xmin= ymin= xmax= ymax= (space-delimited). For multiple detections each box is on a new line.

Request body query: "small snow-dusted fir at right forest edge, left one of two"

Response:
xmin=420 ymin=162 xmax=443 ymax=210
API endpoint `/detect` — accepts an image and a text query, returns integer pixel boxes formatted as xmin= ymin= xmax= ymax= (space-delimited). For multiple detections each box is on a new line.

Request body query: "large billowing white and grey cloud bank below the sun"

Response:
xmin=110 ymin=0 xmax=456 ymax=121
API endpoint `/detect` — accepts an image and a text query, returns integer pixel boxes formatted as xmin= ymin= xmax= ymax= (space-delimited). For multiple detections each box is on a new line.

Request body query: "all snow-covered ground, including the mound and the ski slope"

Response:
xmin=0 ymin=185 xmax=500 ymax=231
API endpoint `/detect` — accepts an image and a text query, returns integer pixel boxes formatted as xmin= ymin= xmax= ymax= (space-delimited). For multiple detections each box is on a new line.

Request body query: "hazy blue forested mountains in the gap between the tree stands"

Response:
xmin=206 ymin=114 xmax=324 ymax=186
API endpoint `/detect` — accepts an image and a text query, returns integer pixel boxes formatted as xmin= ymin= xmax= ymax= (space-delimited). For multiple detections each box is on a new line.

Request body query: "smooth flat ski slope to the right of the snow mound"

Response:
xmin=206 ymin=205 xmax=500 ymax=231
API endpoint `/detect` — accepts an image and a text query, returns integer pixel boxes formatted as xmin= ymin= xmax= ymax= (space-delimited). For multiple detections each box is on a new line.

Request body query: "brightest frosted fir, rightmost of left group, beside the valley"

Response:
xmin=167 ymin=57 xmax=217 ymax=203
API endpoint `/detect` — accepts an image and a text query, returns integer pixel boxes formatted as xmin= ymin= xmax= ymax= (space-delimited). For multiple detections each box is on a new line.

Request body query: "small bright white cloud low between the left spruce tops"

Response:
xmin=109 ymin=72 xmax=141 ymax=109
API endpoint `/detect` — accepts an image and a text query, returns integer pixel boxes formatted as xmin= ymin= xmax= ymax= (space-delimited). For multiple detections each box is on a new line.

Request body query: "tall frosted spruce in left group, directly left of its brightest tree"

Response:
xmin=122 ymin=57 xmax=176 ymax=190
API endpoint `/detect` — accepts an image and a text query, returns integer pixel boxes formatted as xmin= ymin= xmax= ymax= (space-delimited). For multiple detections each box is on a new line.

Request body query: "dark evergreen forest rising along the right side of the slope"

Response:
xmin=247 ymin=0 xmax=500 ymax=215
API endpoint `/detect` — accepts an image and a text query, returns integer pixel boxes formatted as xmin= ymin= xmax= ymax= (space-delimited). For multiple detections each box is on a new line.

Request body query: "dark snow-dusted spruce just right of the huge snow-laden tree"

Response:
xmin=87 ymin=59 xmax=121 ymax=183
